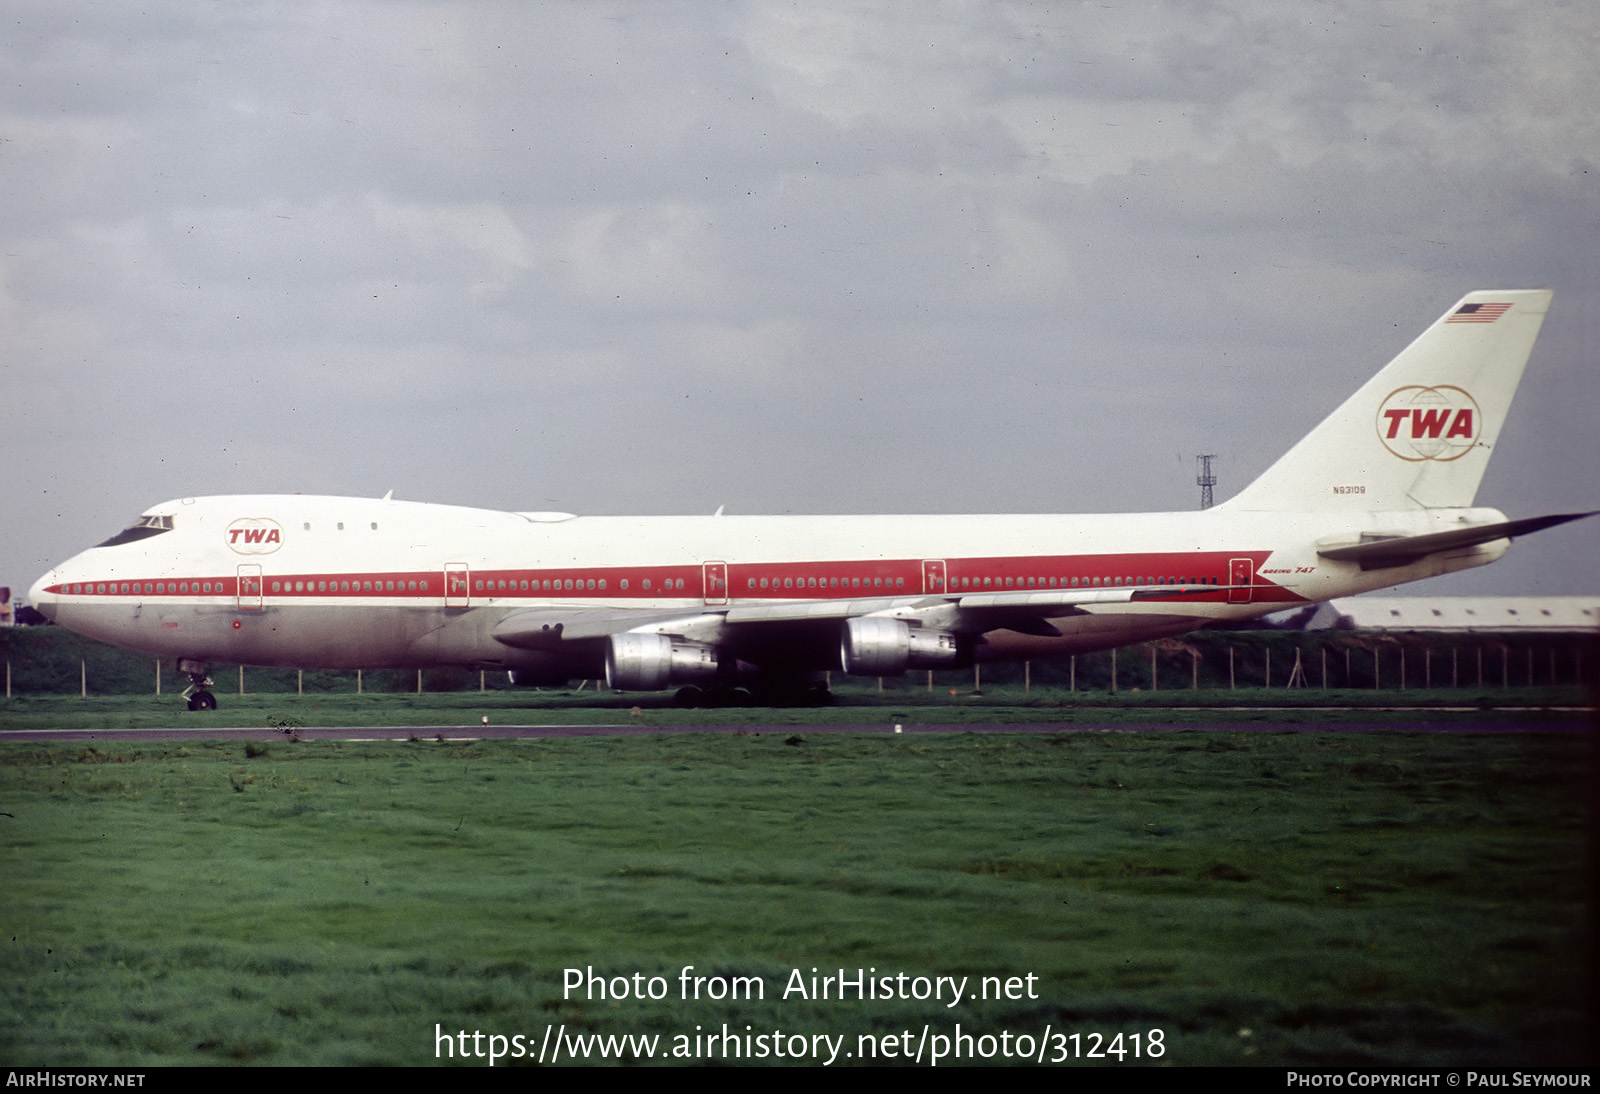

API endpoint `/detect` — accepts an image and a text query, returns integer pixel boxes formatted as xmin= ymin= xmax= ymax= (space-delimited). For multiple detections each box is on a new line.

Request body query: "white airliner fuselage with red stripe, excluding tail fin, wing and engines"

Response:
xmin=32 ymin=494 xmax=1506 ymax=678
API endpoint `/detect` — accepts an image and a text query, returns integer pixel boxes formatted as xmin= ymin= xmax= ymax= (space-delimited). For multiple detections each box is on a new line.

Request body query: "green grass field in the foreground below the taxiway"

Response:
xmin=0 ymin=728 xmax=1592 ymax=1067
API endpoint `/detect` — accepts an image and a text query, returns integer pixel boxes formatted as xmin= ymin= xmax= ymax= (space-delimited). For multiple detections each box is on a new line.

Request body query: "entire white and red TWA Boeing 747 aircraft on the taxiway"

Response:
xmin=30 ymin=291 xmax=1589 ymax=710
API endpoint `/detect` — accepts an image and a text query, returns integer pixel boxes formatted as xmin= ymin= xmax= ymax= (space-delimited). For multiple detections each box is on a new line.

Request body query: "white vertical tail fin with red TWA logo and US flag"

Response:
xmin=1224 ymin=289 xmax=1550 ymax=512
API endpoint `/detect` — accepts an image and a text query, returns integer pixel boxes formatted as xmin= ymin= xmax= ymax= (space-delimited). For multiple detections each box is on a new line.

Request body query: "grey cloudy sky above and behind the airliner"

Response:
xmin=0 ymin=0 xmax=1600 ymax=593
